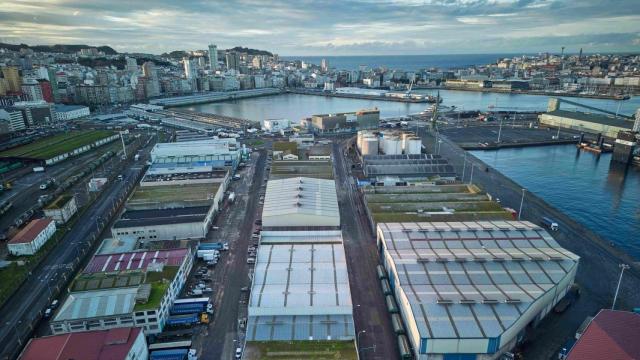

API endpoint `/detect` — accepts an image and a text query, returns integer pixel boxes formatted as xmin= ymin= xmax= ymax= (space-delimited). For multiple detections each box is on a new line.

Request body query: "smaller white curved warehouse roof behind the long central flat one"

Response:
xmin=262 ymin=177 xmax=340 ymax=227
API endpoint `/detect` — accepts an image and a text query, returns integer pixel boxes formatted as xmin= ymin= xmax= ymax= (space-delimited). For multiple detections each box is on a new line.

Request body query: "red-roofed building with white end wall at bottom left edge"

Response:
xmin=18 ymin=327 xmax=149 ymax=360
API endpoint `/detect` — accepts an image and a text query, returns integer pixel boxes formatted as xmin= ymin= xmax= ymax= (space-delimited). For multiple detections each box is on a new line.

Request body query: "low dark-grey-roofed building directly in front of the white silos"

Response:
xmin=362 ymin=154 xmax=456 ymax=183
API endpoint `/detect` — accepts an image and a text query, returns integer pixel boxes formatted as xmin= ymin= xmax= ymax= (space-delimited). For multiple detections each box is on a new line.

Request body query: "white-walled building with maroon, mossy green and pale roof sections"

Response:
xmin=50 ymin=248 xmax=193 ymax=335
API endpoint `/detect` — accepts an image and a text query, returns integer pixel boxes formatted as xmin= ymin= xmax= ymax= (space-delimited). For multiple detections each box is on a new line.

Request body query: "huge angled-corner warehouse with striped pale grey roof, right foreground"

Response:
xmin=377 ymin=221 xmax=579 ymax=360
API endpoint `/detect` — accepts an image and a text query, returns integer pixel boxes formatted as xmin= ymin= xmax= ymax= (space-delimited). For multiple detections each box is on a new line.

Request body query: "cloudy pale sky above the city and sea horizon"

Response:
xmin=0 ymin=0 xmax=640 ymax=56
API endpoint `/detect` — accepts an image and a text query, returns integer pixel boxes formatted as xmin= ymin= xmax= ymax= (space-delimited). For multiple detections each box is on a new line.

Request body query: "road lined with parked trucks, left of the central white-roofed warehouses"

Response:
xmin=194 ymin=150 xmax=266 ymax=359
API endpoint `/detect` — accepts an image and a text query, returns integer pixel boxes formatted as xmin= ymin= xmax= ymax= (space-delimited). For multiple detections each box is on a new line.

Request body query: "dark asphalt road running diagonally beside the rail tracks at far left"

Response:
xmin=0 ymin=162 xmax=143 ymax=359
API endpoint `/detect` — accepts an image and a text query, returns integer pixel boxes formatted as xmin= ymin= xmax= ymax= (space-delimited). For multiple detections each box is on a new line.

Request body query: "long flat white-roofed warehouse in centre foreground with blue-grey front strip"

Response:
xmin=247 ymin=230 xmax=355 ymax=341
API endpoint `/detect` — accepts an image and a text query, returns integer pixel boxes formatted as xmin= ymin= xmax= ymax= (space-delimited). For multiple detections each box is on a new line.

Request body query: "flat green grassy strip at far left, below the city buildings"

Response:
xmin=0 ymin=130 xmax=115 ymax=160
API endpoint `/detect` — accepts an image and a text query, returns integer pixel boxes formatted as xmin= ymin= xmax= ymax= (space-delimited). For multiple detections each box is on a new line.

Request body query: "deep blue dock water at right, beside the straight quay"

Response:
xmin=471 ymin=145 xmax=640 ymax=260
